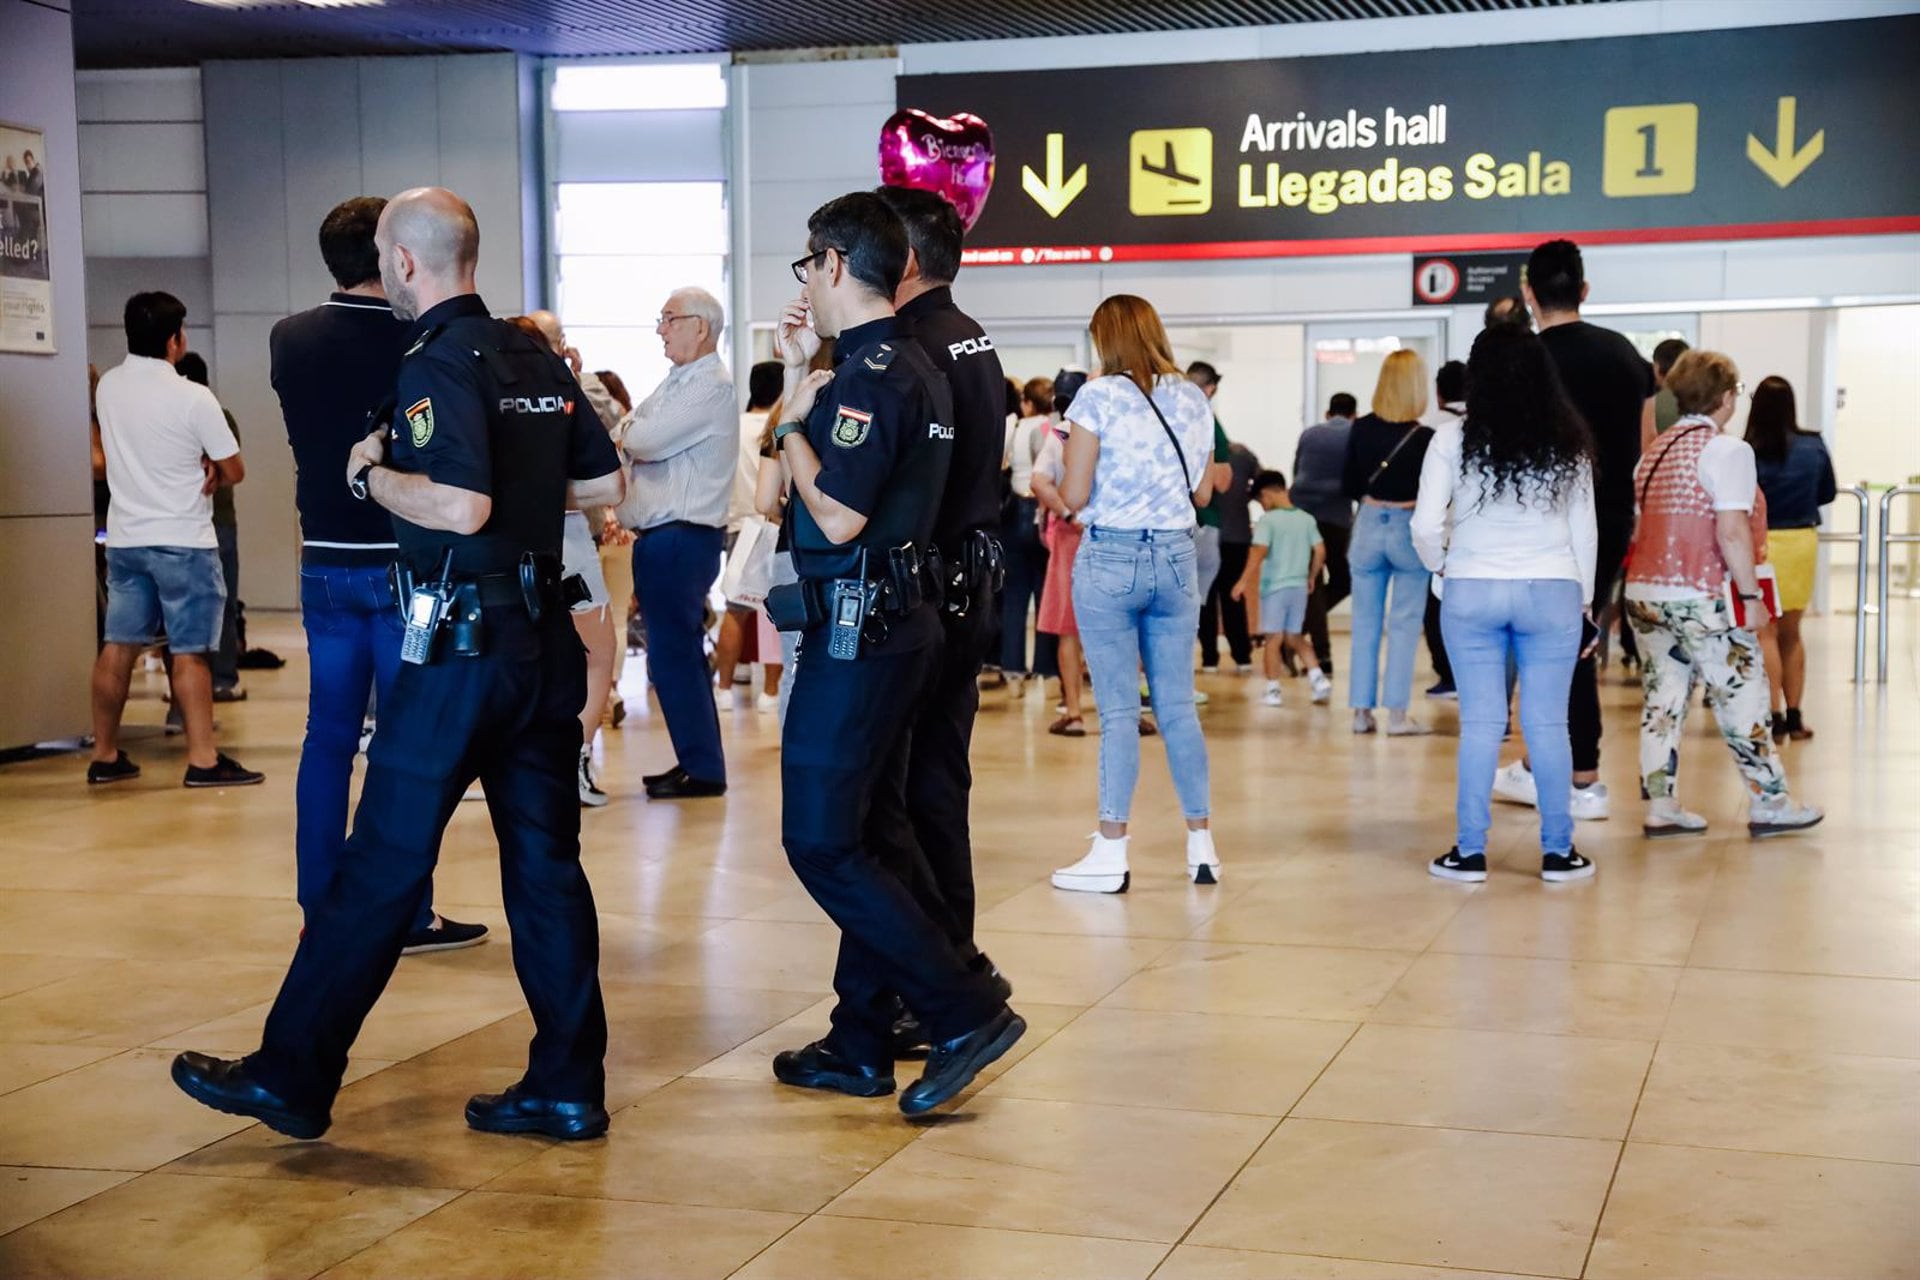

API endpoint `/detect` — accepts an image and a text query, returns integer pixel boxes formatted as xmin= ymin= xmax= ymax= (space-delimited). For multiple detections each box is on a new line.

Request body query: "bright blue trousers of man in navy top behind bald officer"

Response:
xmin=294 ymin=564 xmax=434 ymax=929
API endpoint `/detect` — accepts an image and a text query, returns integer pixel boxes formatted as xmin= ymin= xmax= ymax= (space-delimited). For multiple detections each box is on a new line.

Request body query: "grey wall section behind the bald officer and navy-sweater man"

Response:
xmin=202 ymin=54 xmax=540 ymax=608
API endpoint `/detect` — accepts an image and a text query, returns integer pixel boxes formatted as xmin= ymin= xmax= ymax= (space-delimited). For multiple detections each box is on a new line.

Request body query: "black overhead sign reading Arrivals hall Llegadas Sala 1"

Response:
xmin=897 ymin=15 xmax=1920 ymax=263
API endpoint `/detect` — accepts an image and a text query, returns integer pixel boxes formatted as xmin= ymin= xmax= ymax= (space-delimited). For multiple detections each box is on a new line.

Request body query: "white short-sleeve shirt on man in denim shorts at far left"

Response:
xmin=94 ymin=355 xmax=240 ymax=547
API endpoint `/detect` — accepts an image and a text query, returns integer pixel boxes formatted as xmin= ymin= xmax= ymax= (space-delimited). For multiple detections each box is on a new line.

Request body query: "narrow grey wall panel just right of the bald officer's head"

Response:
xmin=434 ymin=54 xmax=526 ymax=313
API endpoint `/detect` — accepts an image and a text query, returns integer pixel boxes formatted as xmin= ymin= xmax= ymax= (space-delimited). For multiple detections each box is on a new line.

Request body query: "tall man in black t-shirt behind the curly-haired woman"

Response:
xmin=1494 ymin=240 xmax=1655 ymax=819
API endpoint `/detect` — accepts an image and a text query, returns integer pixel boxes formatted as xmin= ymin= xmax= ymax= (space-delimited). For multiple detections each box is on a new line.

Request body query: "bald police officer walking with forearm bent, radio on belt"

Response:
xmin=173 ymin=188 xmax=624 ymax=1138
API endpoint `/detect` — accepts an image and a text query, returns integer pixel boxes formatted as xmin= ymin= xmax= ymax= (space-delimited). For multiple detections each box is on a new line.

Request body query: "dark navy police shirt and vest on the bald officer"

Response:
xmin=388 ymin=294 xmax=620 ymax=574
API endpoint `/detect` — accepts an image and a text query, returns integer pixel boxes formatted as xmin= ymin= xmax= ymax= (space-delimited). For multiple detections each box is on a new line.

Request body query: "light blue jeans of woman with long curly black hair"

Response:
xmin=1440 ymin=578 xmax=1586 ymax=856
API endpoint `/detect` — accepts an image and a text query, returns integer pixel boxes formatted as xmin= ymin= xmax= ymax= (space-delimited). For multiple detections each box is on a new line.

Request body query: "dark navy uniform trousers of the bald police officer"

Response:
xmin=248 ymin=606 xmax=607 ymax=1107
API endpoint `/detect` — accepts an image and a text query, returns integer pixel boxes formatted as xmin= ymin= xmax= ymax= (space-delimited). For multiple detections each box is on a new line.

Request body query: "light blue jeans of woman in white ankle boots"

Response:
xmin=1073 ymin=528 xmax=1210 ymax=821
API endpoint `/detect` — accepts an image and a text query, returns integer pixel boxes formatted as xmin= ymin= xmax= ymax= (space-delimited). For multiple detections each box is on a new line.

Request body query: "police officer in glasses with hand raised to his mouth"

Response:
xmin=768 ymin=192 xmax=1027 ymax=1115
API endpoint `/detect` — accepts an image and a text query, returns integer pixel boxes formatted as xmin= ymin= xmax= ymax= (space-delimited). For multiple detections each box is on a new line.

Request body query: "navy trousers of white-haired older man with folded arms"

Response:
xmin=634 ymin=524 xmax=732 ymax=783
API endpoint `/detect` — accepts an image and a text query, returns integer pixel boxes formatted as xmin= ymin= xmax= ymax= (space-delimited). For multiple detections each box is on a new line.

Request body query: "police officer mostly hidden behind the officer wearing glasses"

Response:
xmin=876 ymin=186 xmax=1006 ymax=982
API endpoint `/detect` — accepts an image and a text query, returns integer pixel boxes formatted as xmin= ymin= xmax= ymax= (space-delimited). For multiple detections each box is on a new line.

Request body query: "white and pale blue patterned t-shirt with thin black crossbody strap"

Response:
xmin=1066 ymin=374 xmax=1213 ymax=530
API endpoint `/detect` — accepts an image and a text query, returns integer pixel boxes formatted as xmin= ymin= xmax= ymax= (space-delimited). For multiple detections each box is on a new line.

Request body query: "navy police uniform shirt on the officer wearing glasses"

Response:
xmin=791 ymin=317 xmax=954 ymax=580
